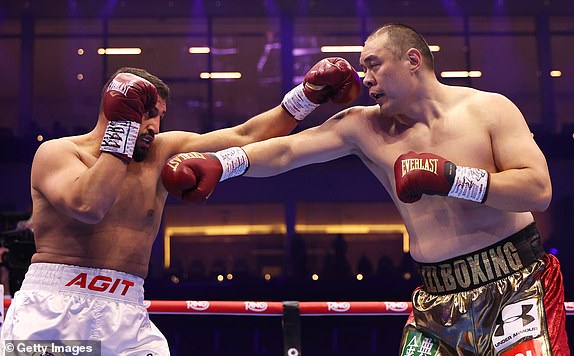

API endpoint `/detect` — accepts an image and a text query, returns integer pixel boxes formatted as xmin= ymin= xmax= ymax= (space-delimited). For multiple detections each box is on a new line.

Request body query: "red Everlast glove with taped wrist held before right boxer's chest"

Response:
xmin=394 ymin=151 xmax=489 ymax=203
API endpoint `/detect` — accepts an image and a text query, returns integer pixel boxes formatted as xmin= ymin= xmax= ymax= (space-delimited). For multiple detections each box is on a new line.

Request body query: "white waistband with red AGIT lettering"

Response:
xmin=20 ymin=263 xmax=144 ymax=304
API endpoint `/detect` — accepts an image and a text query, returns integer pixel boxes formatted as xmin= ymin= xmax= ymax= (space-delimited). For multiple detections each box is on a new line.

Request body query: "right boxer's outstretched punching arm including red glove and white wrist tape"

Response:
xmin=161 ymin=108 xmax=357 ymax=202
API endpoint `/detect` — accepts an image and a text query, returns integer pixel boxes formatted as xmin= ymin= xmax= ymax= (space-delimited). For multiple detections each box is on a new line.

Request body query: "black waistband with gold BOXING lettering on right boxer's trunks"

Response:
xmin=417 ymin=223 xmax=546 ymax=295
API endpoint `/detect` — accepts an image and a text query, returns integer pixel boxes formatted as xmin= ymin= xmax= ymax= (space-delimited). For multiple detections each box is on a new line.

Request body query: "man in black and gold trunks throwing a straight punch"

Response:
xmin=162 ymin=24 xmax=570 ymax=356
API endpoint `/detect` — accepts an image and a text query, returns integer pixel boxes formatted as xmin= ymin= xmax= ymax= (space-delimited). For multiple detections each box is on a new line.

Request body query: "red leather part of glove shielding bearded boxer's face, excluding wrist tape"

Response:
xmin=102 ymin=73 xmax=157 ymax=123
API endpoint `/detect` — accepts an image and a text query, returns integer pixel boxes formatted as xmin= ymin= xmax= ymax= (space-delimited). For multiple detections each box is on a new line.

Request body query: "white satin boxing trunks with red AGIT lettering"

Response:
xmin=1 ymin=263 xmax=170 ymax=356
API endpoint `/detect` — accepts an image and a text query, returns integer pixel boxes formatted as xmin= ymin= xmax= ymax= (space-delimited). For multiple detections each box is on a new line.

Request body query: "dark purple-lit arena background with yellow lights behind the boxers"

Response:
xmin=0 ymin=0 xmax=574 ymax=355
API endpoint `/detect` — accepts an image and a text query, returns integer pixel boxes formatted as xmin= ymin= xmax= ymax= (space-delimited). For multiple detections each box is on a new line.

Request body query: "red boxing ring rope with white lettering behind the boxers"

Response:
xmin=4 ymin=298 xmax=574 ymax=316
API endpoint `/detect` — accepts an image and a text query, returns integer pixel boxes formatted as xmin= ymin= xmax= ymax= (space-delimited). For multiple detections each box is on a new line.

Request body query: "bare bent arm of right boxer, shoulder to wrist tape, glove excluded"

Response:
xmin=482 ymin=94 xmax=552 ymax=211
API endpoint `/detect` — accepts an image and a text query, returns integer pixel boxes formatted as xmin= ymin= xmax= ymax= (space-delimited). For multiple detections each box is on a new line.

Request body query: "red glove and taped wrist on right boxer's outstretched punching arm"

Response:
xmin=161 ymin=147 xmax=249 ymax=202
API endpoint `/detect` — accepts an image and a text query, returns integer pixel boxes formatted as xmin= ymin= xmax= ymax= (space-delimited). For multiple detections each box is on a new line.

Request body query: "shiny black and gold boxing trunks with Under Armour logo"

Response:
xmin=401 ymin=223 xmax=570 ymax=356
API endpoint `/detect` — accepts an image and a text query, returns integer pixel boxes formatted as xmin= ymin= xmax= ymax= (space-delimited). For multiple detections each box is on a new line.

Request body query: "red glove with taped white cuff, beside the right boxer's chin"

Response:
xmin=281 ymin=57 xmax=361 ymax=120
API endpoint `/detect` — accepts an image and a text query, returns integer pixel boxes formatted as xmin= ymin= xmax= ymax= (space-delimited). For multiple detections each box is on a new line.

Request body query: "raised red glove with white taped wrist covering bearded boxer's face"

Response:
xmin=100 ymin=73 xmax=157 ymax=162
